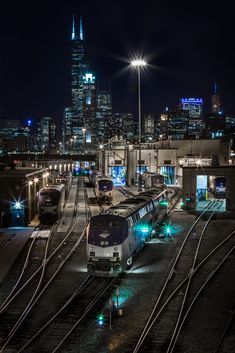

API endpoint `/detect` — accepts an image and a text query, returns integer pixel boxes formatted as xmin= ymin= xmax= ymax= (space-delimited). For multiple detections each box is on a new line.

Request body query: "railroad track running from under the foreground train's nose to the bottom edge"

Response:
xmin=8 ymin=275 xmax=116 ymax=353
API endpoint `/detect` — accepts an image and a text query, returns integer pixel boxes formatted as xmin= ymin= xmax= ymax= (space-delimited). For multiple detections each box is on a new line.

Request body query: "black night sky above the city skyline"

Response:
xmin=0 ymin=0 xmax=235 ymax=126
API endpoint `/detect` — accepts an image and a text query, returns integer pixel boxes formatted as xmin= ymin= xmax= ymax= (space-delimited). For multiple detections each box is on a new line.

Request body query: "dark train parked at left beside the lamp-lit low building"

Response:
xmin=37 ymin=184 xmax=66 ymax=223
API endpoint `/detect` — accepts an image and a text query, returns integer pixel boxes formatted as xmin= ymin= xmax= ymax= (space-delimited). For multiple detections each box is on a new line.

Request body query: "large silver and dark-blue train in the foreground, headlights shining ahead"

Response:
xmin=87 ymin=189 xmax=167 ymax=276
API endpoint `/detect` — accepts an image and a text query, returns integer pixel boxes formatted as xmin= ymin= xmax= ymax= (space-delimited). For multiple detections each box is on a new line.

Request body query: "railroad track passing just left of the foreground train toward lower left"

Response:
xmin=0 ymin=180 xmax=92 ymax=352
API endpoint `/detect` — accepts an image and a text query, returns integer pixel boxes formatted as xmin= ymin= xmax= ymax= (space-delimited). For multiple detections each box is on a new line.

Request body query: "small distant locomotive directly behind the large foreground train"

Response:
xmin=95 ymin=175 xmax=114 ymax=202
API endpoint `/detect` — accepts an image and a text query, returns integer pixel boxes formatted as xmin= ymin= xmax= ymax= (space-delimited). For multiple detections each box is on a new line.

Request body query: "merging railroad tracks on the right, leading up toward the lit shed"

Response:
xmin=125 ymin=202 xmax=235 ymax=353
